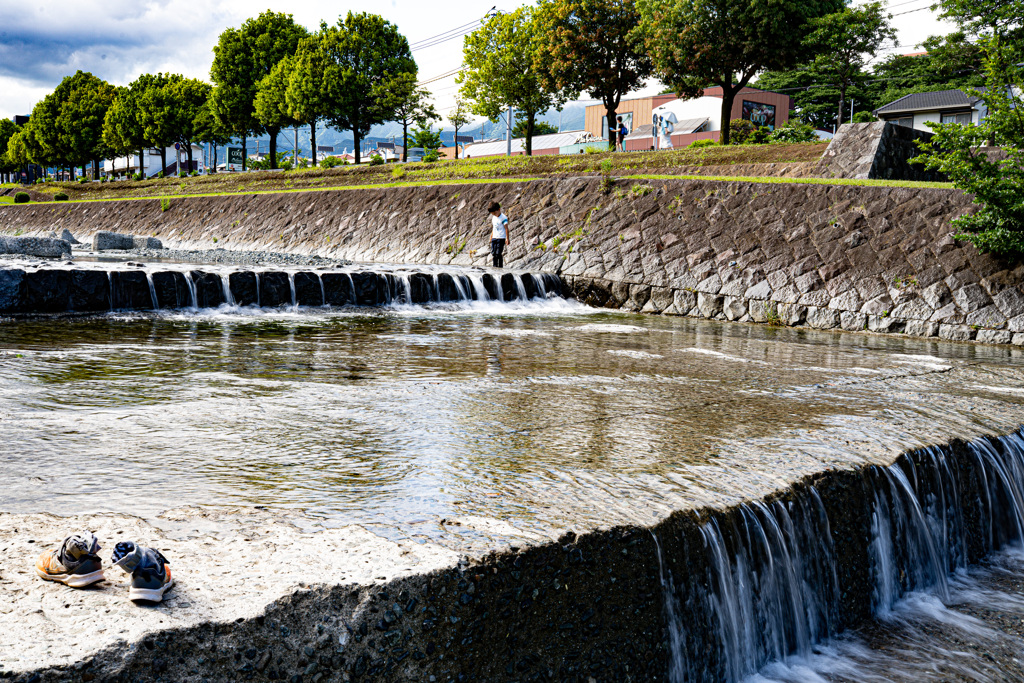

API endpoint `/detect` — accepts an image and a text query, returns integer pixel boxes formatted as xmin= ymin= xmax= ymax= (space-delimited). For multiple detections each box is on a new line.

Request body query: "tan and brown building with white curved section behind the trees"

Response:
xmin=584 ymin=86 xmax=790 ymax=152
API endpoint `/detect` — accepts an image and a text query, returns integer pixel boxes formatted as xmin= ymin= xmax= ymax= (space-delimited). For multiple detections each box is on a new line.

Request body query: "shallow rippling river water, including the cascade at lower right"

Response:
xmin=0 ymin=282 xmax=1024 ymax=683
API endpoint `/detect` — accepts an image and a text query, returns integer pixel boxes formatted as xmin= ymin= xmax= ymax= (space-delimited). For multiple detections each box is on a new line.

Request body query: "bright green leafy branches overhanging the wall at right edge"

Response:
xmin=913 ymin=40 xmax=1024 ymax=259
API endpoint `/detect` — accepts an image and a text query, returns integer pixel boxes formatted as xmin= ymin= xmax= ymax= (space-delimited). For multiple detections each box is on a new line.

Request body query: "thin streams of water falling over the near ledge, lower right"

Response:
xmin=655 ymin=432 xmax=1024 ymax=683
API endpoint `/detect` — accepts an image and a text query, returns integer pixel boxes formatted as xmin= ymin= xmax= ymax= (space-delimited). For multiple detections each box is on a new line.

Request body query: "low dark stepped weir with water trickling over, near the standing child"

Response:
xmin=0 ymin=264 xmax=562 ymax=315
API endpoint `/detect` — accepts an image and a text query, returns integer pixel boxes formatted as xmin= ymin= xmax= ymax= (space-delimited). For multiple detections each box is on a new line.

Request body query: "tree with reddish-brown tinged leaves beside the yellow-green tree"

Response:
xmin=534 ymin=0 xmax=653 ymax=150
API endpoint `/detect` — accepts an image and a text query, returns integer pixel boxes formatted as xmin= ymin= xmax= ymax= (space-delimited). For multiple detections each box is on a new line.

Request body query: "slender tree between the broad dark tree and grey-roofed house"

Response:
xmin=806 ymin=2 xmax=896 ymax=130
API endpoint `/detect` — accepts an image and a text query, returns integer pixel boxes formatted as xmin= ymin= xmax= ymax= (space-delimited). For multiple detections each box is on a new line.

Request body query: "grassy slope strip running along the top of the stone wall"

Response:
xmin=2 ymin=143 xmax=949 ymax=202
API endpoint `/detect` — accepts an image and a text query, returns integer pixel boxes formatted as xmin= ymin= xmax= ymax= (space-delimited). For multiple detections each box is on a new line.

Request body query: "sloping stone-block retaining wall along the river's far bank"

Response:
xmin=0 ymin=178 xmax=1024 ymax=345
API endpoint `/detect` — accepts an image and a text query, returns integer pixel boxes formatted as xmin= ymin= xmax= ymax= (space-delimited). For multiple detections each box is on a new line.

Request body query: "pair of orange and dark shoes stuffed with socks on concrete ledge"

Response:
xmin=36 ymin=531 xmax=174 ymax=602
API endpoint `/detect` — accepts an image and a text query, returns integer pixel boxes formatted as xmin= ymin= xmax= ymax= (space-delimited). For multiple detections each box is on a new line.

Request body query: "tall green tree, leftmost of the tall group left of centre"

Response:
xmin=210 ymin=11 xmax=307 ymax=163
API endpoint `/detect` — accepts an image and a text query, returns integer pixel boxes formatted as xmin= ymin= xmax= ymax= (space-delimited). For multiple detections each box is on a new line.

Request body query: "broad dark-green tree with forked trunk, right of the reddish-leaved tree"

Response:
xmin=637 ymin=0 xmax=845 ymax=144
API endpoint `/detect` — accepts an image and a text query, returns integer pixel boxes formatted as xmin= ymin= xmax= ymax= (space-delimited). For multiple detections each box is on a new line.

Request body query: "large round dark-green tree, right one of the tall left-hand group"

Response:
xmin=321 ymin=12 xmax=417 ymax=163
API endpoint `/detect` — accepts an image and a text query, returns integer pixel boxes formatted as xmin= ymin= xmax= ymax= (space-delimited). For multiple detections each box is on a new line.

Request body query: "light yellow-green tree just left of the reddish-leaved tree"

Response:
xmin=456 ymin=7 xmax=565 ymax=157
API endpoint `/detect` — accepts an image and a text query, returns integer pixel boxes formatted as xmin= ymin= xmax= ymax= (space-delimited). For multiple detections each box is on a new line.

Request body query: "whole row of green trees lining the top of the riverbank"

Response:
xmin=0 ymin=0 xmax=1024 ymax=181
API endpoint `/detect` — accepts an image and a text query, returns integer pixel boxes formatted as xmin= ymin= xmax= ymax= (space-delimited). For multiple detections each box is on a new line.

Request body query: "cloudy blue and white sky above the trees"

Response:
xmin=0 ymin=0 xmax=949 ymax=118
